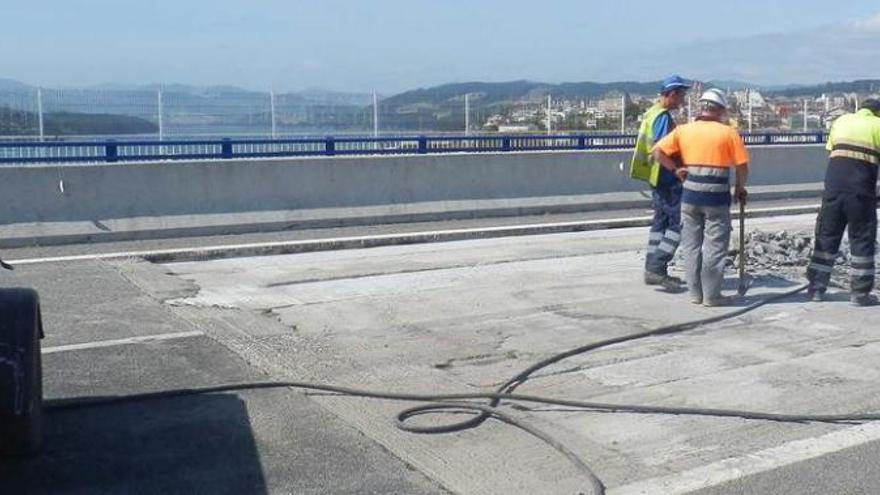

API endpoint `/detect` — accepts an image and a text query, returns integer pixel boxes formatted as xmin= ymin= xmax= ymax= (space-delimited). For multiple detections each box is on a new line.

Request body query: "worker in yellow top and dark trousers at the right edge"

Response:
xmin=807 ymin=98 xmax=880 ymax=306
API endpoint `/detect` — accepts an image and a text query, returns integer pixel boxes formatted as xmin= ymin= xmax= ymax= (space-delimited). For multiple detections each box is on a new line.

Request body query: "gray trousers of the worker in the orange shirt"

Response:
xmin=679 ymin=203 xmax=730 ymax=301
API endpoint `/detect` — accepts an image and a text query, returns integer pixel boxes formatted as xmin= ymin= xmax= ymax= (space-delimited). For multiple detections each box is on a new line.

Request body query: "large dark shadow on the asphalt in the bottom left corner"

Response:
xmin=0 ymin=394 xmax=267 ymax=494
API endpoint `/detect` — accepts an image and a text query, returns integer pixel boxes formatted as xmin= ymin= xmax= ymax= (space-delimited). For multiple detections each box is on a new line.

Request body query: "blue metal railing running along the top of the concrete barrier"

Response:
xmin=0 ymin=133 xmax=826 ymax=164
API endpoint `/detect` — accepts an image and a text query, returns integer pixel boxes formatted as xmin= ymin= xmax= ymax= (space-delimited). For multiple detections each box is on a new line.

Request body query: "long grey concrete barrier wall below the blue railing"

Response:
xmin=0 ymin=145 xmax=827 ymax=245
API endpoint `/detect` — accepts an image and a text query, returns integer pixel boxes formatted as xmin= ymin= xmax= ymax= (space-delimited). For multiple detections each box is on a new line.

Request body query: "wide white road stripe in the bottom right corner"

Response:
xmin=608 ymin=422 xmax=880 ymax=495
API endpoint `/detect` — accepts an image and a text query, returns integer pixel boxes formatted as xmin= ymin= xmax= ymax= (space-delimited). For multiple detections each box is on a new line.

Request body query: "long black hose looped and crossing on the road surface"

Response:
xmin=51 ymin=285 xmax=880 ymax=494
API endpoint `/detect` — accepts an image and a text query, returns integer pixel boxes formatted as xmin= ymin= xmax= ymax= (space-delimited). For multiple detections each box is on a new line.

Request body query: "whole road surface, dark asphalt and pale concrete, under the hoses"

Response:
xmin=1 ymin=211 xmax=880 ymax=494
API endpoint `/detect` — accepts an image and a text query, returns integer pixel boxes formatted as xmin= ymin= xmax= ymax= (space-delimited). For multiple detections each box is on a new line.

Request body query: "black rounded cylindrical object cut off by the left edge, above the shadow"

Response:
xmin=0 ymin=288 xmax=43 ymax=457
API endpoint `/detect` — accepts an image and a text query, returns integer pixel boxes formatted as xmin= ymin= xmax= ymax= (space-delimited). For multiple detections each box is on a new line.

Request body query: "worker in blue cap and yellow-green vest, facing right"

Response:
xmin=630 ymin=75 xmax=690 ymax=290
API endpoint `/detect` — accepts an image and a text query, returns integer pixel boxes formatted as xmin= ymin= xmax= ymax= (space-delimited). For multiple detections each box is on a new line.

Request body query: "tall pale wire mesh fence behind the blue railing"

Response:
xmin=0 ymin=85 xmax=848 ymax=140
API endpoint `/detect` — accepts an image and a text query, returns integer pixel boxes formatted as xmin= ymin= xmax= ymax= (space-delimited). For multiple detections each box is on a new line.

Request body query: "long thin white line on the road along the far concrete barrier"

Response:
xmin=7 ymin=205 xmax=819 ymax=265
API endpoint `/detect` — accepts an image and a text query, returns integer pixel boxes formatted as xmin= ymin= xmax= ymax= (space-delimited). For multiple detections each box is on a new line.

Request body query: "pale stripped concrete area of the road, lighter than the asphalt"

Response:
xmin=150 ymin=216 xmax=880 ymax=493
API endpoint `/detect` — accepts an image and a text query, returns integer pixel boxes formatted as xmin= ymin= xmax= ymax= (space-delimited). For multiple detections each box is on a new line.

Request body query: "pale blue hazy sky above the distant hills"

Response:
xmin=0 ymin=0 xmax=880 ymax=94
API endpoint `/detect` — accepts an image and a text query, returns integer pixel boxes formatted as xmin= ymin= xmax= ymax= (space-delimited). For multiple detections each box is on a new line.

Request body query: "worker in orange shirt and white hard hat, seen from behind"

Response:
xmin=653 ymin=89 xmax=749 ymax=306
